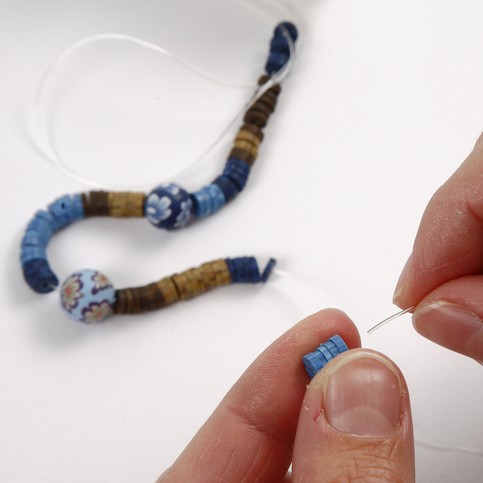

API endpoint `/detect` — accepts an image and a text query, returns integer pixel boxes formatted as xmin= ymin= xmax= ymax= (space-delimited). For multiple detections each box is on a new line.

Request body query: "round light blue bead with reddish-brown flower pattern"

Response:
xmin=60 ymin=270 xmax=115 ymax=324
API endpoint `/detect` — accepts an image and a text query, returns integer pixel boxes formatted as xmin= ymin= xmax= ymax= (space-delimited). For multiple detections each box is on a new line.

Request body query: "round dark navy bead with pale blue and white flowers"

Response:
xmin=144 ymin=183 xmax=193 ymax=230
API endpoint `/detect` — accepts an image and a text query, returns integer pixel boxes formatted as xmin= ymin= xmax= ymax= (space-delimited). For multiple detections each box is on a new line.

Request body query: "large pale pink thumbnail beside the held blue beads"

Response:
xmin=324 ymin=351 xmax=402 ymax=436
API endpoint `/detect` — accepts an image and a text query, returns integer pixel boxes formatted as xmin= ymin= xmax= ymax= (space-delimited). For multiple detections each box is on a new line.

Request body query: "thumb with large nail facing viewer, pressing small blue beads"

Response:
xmin=292 ymin=349 xmax=415 ymax=483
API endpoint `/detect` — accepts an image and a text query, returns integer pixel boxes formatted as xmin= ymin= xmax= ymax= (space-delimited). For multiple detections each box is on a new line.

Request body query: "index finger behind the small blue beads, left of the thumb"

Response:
xmin=158 ymin=309 xmax=360 ymax=483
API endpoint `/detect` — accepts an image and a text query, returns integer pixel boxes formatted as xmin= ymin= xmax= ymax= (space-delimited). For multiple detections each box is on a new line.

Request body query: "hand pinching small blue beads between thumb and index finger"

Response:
xmin=158 ymin=310 xmax=414 ymax=483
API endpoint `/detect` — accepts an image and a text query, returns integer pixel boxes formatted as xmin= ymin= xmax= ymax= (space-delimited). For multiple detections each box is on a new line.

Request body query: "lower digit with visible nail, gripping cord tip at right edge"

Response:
xmin=413 ymin=300 xmax=483 ymax=362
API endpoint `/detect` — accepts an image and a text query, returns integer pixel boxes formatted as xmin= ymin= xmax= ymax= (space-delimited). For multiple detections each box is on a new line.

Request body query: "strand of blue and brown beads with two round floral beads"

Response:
xmin=20 ymin=22 xmax=298 ymax=323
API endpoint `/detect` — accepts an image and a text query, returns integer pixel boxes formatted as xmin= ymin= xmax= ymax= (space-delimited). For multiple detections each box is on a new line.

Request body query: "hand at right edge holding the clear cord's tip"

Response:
xmin=394 ymin=134 xmax=483 ymax=363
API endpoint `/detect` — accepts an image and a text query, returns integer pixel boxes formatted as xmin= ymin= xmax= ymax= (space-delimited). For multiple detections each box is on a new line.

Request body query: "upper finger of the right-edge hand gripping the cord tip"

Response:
xmin=394 ymin=134 xmax=483 ymax=308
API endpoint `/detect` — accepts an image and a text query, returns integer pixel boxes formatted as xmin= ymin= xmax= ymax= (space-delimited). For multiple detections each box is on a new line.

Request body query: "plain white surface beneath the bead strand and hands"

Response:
xmin=0 ymin=0 xmax=483 ymax=483
